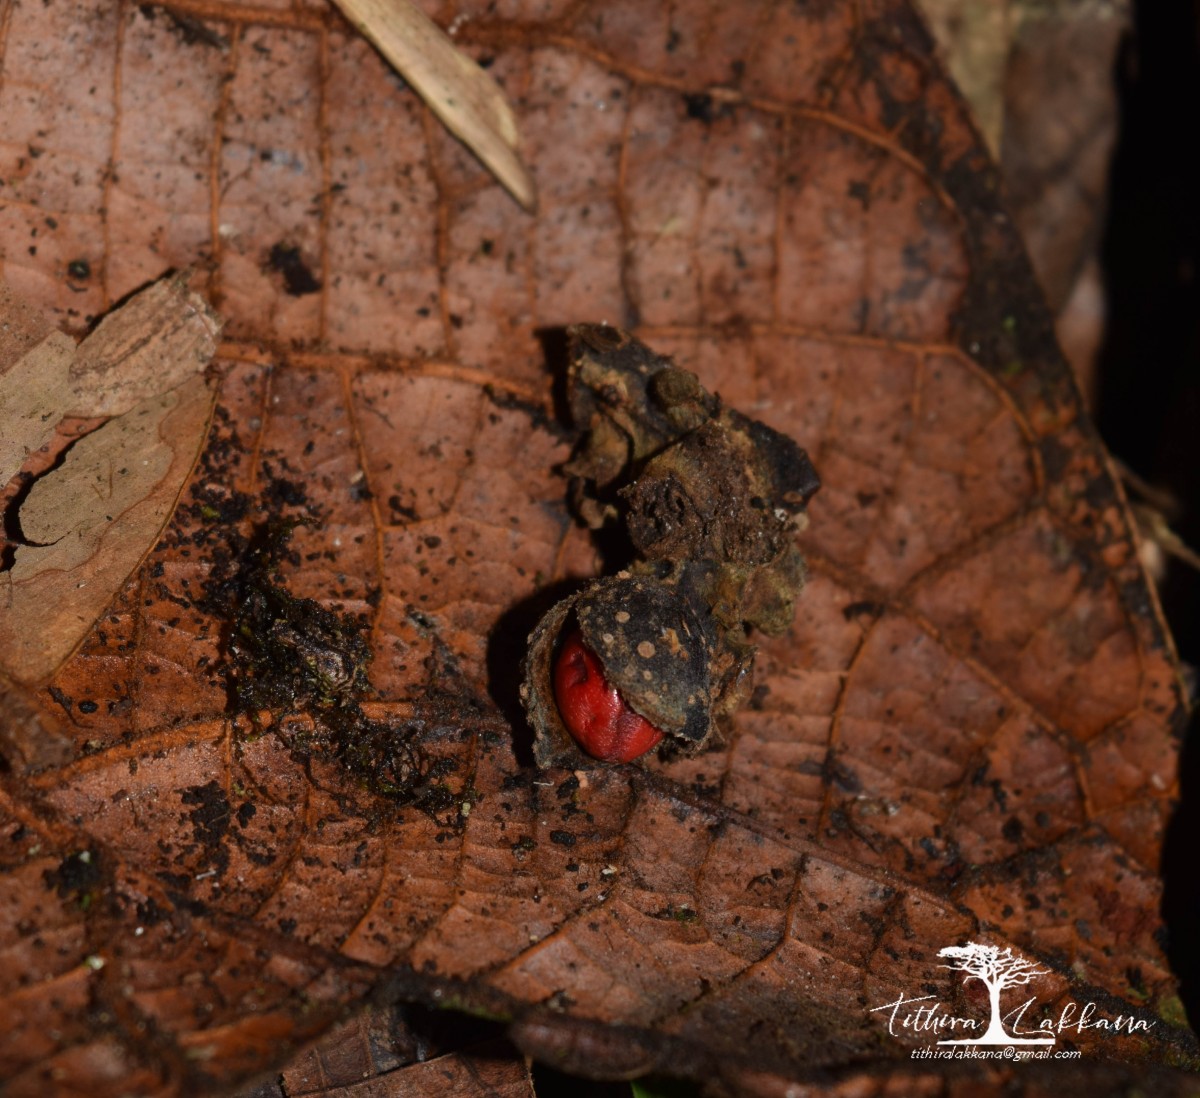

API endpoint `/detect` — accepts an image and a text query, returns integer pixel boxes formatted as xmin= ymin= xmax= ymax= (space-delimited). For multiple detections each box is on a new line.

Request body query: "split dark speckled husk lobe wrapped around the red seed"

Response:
xmin=521 ymin=572 xmax=715 ymax=767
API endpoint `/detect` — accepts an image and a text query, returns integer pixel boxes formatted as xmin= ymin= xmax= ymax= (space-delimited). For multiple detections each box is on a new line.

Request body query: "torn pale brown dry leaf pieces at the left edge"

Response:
xmin=0 ymin=277 xmax=221 ymax=684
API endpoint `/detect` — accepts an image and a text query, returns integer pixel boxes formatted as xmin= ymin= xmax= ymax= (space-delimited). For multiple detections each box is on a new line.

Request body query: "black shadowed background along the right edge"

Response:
xmin=1096 ymin=0 xmax=1200 ymax=1028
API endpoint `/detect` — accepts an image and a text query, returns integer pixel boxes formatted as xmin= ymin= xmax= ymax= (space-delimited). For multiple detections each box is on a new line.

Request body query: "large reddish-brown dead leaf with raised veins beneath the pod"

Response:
xmin=0 ymin=0 xmax=1196 ymax=1094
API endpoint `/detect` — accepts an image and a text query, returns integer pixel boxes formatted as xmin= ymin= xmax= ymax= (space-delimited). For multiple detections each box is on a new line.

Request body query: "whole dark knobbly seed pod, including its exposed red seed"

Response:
xmin=521 ymin=325 xmax=820 ymax=767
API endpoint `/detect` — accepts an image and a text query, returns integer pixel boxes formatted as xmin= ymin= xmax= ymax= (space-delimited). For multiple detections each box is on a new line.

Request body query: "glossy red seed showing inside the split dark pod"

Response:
xmin=554 ymin=631 xmax=662 ymax=762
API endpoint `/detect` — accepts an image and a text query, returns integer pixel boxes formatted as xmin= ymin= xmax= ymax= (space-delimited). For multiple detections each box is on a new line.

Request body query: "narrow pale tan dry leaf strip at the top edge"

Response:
xmin=335 ymin=0 xmax=536 ymax=210
